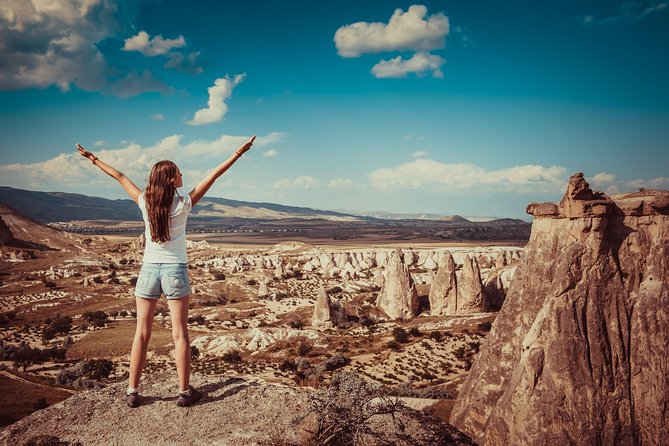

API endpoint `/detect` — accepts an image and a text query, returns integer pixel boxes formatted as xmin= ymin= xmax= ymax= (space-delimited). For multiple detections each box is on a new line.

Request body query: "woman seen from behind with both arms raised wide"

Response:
xmin=77 ymin=136 xmax=255 ymax=407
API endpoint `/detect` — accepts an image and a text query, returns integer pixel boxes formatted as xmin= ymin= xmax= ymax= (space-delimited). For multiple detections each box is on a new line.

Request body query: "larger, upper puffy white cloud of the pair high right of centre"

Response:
xmin=334 ymin=5 xmax=449 ymax=57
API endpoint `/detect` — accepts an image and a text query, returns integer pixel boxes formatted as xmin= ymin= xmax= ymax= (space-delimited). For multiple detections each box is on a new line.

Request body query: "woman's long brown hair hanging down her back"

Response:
xmin=144 ymin=160 xmax=179 ymax=242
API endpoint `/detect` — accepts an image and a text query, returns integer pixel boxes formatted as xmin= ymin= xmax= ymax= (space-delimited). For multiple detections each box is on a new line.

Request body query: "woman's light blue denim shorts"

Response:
xmin=135 ymin=263 xmax=190 ymax=299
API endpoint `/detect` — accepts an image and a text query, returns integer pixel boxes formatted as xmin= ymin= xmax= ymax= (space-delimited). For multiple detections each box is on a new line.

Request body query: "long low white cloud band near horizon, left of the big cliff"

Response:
xmin=369 ymin=159 xmax=567 ymax=193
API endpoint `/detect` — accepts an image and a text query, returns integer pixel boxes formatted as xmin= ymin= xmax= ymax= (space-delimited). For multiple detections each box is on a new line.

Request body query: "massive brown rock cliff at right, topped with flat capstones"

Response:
xmin=451 ymin=174 xmax=669 ymax=445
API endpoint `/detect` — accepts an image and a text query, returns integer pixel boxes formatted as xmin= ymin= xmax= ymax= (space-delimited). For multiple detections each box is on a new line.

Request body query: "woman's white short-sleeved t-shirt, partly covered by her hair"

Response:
xmin=137 ymin=191 xmax=193 ymax=263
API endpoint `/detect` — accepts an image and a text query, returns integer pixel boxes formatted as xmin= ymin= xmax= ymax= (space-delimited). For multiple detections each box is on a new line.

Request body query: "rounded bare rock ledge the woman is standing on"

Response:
xmin=0 ymin=372 xmax=474 ymax=446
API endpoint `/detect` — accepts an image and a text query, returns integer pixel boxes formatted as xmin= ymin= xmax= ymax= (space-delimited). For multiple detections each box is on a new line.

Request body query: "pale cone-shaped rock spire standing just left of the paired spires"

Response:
xmin=376 ymin=249 xmax=418 ymax=319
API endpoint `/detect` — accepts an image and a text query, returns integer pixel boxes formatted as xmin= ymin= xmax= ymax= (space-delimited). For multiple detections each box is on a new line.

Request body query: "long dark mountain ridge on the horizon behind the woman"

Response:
xmin=0 ymin=187 xmax=361 ymax=223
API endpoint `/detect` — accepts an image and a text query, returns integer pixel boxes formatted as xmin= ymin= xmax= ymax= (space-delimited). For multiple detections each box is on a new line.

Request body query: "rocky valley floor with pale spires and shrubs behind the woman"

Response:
xmin=0 ymin=199 xmax=523 ymax=444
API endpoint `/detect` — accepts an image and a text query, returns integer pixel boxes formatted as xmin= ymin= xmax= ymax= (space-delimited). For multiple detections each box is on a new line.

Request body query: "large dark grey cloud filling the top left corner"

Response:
xmin=0 ymin=0 xmax=169 ymax=97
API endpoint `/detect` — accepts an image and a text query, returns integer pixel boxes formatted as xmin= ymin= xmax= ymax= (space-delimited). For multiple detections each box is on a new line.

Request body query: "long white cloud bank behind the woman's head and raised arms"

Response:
xmin=0 ymin=132 xmax=284 ymax=192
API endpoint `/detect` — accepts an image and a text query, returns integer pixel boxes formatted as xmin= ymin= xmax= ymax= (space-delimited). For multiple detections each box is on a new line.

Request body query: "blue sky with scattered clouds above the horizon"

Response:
xmin=0 ymin=0 xmax=669 ymax=217
